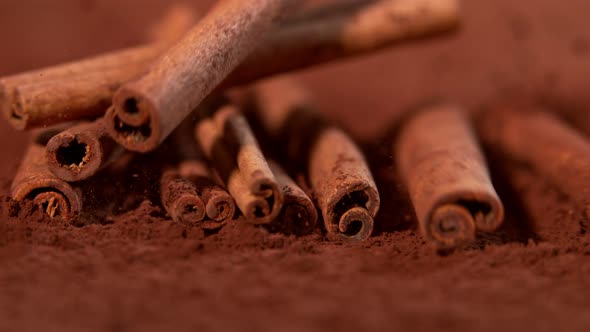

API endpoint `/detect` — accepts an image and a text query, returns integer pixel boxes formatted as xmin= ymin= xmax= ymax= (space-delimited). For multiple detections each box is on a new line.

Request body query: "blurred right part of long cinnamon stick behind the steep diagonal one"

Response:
xmin=227 ymin=0 xmax=460 ymax=87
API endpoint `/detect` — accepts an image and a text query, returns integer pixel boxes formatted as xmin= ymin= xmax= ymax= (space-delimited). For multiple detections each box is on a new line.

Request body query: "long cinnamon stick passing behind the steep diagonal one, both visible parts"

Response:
xmin=0 ymin=0 xmax=459 ymax=130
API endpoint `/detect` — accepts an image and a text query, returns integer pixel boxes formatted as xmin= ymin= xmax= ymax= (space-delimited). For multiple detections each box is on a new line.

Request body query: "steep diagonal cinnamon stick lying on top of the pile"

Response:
xmin=111 ymin=0 xmax=302 ymax=152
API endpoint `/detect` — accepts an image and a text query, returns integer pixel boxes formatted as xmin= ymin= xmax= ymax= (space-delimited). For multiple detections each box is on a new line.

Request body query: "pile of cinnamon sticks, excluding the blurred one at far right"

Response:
xmin=0 ymin=0 xmax=528 ymax=249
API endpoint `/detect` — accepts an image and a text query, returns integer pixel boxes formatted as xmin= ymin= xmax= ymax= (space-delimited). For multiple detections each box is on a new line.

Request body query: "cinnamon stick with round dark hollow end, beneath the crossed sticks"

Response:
xmin=46 ymin=119 xmax=124 ymax=182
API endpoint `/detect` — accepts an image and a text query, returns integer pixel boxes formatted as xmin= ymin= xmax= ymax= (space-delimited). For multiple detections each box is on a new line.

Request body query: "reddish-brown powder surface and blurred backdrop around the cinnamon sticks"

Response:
xmin=0 ymin=0 xmax=590 ymax=331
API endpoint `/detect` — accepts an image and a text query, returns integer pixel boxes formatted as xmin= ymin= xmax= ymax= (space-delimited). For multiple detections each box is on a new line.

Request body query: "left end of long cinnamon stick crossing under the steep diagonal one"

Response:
xmin=0 ymin=5 xmax=196 ymax=130
